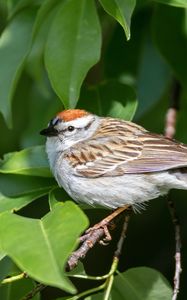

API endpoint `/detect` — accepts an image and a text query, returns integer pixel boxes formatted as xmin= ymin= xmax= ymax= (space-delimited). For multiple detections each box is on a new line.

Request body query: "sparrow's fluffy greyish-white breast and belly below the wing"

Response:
xmin=54 ymin=157 xmax=187 ymax=209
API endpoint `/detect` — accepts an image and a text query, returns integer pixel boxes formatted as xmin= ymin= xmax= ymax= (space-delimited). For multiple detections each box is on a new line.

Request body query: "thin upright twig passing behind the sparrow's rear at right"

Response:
xmin=165 ymin=80 xmax=182 ymax=300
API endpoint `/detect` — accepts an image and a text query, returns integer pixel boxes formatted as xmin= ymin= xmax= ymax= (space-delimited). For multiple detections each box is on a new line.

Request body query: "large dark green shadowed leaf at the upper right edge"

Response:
xmin=153 ymin=5 xmax=187 ymax=89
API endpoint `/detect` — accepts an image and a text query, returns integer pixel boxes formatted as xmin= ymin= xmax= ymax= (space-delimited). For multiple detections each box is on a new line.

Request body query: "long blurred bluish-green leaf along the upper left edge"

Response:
xmin=0 ymin=9 xmax=35 ymax=125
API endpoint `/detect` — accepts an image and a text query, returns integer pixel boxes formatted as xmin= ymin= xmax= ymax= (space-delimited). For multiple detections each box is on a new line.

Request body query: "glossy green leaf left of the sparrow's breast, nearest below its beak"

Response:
xmin=0 ymin=146 xmax=52 ymax=177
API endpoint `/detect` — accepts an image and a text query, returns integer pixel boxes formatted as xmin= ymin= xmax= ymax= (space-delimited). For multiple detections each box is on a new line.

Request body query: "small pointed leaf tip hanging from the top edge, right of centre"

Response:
xmin=99 ymin=0 xmax=136 ymax=40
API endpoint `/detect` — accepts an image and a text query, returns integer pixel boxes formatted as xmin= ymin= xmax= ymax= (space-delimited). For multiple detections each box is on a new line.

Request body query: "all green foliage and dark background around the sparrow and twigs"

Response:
xmin=0 ymin=0 xmax=187 ymax=300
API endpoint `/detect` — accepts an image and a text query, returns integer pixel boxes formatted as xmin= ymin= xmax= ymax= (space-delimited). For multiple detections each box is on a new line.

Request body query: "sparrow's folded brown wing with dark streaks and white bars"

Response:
xmin=66 ymin=122 xmax=187 ymax=178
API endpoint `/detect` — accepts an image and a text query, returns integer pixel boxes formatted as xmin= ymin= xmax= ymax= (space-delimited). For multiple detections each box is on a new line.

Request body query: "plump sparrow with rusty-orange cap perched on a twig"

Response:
xmin=40 ymin=109 xmax=187 ymax=211
